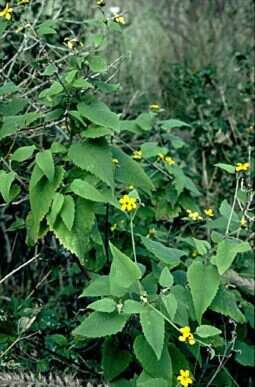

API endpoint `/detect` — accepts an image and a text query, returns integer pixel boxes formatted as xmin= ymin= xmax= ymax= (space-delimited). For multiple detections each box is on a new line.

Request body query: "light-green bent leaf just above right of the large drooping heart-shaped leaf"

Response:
xmin=213 ymin=239 xmax=251 ymax=275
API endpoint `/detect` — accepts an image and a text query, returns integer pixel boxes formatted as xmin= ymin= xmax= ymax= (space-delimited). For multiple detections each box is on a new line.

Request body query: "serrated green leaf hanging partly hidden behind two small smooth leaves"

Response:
xmin=47 ymin=198 xmax=95 ymax=265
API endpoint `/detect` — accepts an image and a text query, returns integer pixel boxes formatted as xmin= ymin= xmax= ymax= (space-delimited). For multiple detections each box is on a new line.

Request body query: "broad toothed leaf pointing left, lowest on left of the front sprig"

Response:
xmin=72 ymin=312 xmax=129 ymax=338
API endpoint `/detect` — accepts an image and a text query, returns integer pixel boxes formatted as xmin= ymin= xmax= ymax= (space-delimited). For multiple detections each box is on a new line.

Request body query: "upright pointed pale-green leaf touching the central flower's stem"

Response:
xmin=110 ymin=243 xmax=142 ymax=297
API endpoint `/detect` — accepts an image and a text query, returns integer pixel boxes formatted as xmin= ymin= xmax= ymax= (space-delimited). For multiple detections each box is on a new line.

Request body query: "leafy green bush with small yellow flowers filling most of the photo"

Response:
xmin=0 ymin=2 xmax=254 ymax=387
